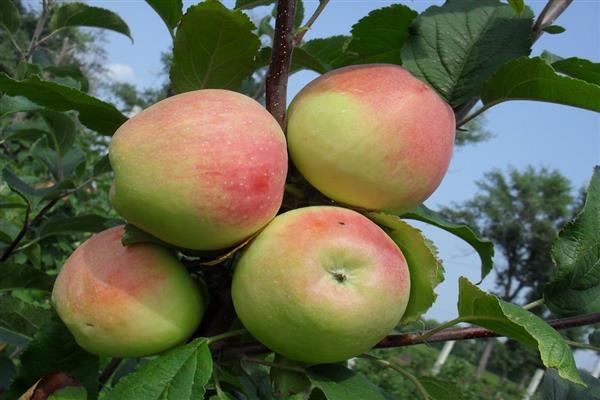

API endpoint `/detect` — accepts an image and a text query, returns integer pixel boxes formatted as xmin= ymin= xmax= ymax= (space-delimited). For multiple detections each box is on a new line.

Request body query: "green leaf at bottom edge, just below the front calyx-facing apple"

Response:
xmin=308 ymin=364 xmax=385 ymax=400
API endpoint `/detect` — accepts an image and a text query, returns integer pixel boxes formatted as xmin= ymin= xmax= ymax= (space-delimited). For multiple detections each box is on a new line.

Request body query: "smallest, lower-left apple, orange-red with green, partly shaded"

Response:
xmin=52 ymin=226 xmax=205 ymax=357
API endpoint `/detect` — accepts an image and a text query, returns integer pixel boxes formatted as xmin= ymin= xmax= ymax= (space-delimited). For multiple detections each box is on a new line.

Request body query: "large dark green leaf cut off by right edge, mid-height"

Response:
xmin=544 ymin=167 xmax=600 ymax=316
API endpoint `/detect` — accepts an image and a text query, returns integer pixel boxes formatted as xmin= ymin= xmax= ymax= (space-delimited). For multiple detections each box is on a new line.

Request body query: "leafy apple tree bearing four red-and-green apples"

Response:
xmin=0 ymin=0 xmax=600 ymax=400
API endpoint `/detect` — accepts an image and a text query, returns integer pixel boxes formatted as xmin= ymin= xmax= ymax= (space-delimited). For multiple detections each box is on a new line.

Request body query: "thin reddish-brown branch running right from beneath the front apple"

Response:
xmin=223 ymin=312 xmax=600 ymax=357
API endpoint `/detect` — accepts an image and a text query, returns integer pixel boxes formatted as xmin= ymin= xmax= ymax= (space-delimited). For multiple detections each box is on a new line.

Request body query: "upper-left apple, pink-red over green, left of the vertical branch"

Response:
xmin=109 ymin=89 xmax=287 ymax=250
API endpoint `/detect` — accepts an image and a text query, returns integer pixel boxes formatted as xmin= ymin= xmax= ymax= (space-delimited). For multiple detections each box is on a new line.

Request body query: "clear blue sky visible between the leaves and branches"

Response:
xmin=89 ymin=0 xmax=600 ymax=368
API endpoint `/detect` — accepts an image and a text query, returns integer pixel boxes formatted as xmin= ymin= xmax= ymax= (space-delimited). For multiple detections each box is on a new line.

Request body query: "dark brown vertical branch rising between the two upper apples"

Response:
xmin=266 ymin=0 xmax=296 ymax=128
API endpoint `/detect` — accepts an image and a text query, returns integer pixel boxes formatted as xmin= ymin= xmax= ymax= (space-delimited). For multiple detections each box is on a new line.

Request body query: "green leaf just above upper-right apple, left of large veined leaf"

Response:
xmin=344 ymin=4 xmax=417 ymax=65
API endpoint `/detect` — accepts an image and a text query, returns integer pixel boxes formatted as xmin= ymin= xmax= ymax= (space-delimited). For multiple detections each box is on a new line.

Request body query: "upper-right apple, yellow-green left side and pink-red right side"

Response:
xmin=287 ymin=64 xmax=455 ymax=212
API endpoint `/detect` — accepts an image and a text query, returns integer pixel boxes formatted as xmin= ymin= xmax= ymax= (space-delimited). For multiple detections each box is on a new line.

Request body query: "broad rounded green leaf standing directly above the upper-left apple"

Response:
xmin=170 ymin=0 xmax=260 ymax=93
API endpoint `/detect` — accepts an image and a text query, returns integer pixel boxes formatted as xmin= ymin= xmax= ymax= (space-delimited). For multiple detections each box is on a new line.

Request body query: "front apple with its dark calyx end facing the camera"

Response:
xmin=231 ymin=206 xmax=410 ymax=364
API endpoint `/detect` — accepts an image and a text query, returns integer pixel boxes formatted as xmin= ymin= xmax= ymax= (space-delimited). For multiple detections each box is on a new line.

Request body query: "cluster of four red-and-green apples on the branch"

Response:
xmin=52 ymin=64 xmax=454 ymax=363
